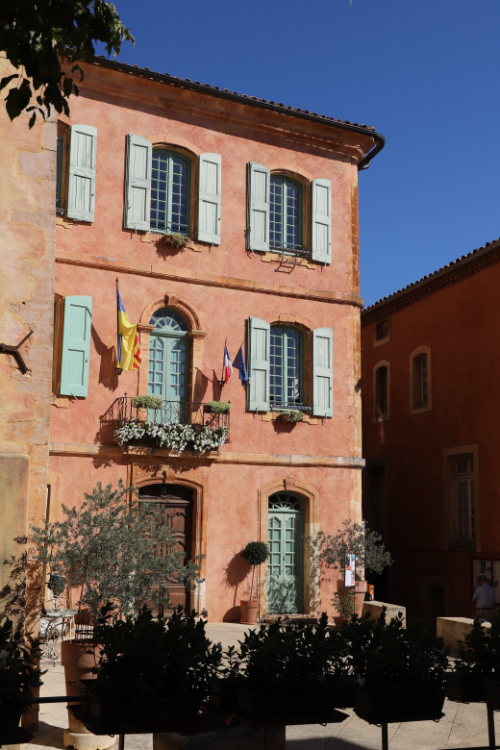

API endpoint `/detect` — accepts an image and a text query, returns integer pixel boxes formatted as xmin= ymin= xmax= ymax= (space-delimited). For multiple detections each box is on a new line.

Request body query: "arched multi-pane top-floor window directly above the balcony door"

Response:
xmin=150 ymin=148 xmax=191 ymax=235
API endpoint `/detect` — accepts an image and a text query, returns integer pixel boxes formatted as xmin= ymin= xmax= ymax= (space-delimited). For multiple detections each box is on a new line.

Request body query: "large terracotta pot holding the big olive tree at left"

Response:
xmin=61 ymin=641 xmax=115 ymax=750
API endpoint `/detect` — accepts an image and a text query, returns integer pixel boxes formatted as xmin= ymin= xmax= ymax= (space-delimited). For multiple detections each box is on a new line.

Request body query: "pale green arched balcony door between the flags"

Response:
xmin=148 ymin=307 xmax=189 ymax=423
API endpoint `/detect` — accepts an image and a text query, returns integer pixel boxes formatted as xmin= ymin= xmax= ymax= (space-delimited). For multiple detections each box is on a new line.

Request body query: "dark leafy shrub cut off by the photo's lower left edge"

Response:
xmin=0 ymin=618 xmax=45 ymax=745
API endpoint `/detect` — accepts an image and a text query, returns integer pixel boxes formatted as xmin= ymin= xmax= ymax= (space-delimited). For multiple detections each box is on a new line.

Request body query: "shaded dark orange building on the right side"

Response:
xmin=361 ymin=240 xmax=500 ymax=625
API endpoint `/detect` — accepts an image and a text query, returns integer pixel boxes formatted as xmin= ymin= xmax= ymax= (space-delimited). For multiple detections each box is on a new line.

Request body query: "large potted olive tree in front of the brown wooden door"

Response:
xmin=32 ymin=480 xmax=200 ymax=750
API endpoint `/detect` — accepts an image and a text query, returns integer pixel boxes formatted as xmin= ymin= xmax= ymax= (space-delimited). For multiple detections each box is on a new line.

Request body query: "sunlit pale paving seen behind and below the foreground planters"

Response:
xmin=22 ymin=623 xmax=500 ymax=750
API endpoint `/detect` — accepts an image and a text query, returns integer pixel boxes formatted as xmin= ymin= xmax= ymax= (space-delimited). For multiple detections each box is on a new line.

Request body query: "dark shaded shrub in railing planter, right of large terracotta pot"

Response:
xmin=79 ymin=605 xmax=222 ymax=733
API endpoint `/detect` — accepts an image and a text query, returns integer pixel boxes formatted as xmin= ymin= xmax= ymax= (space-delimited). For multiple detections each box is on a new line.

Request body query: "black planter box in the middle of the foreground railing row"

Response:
xmin=238 ymin=689 xmax=335 ymax=721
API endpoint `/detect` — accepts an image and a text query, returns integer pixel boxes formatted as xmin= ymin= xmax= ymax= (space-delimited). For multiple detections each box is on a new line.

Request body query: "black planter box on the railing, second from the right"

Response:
xmin=356 ymin=688 xmax=445 ymax=724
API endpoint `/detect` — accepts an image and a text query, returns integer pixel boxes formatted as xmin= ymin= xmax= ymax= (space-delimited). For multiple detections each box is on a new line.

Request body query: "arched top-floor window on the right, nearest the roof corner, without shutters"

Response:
xmin=269 ymin=174 xmax=302 ymax=251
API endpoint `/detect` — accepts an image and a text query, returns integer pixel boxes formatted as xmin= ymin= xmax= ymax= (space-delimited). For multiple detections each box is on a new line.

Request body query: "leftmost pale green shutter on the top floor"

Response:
xmin=68 ymin=125 xmax=97 ymax=221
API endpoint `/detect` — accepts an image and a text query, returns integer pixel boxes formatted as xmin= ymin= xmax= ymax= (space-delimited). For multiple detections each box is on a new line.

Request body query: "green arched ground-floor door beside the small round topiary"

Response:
xmin=267 ymin=492 xmax=304 ymax=614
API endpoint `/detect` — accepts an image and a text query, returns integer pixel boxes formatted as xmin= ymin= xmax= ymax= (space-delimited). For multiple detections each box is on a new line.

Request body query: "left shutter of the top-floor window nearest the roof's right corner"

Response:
xmin=247 ymin=162 xmax=271 ymax=252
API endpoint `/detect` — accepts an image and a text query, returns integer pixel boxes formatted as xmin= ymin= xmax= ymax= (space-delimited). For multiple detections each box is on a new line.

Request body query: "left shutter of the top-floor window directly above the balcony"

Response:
xmin=124 ymin=133 xmax=153 ymax=232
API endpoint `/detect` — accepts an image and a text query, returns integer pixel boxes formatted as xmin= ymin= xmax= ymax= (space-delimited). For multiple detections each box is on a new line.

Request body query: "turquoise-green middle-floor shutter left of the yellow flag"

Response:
xmin=59 ymin=297 xmax=92 ymax=398
